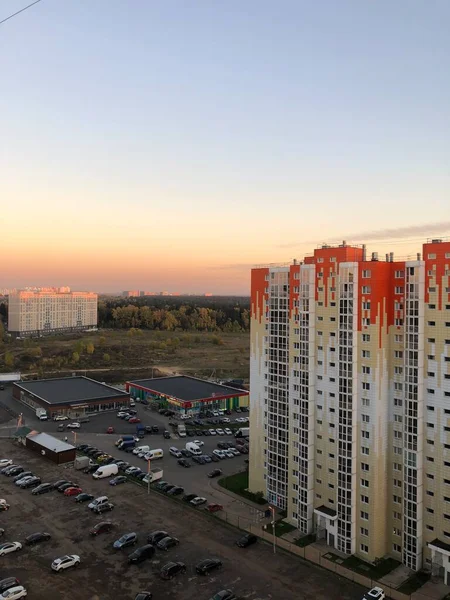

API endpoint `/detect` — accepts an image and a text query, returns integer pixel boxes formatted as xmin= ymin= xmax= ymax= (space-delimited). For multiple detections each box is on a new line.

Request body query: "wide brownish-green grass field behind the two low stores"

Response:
xmin=0 ymin=330 xmax=250 ymax=382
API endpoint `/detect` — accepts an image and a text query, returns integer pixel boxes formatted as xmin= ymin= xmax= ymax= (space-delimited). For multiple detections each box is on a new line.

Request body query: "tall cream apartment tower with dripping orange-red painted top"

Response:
xmin=249 ymin=239 xmax=450 ymax=584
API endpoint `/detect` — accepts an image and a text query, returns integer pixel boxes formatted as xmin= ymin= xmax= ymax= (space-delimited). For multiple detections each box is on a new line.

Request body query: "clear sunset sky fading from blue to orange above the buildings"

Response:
xmin=0 ymin=0 xmax=450 ymax=294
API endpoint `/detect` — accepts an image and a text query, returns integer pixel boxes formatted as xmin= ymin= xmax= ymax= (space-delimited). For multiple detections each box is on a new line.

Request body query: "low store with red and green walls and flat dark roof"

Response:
xmin=126 ymin=375 xmax=249 ymax=415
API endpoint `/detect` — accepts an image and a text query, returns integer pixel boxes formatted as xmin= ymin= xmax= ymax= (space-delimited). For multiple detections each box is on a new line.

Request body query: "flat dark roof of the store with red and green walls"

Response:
xmin=129 ymin=375 xmax=248 ymax=402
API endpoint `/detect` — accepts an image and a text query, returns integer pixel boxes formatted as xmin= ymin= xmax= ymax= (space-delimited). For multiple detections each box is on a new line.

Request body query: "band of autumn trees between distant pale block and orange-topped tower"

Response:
xmin=98 ymin=297 xmax=250 ymax=333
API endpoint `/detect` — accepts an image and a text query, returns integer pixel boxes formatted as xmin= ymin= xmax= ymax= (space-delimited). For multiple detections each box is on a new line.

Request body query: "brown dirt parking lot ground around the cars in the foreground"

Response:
xmin=0 ymin=441 xmax=363 ymax=600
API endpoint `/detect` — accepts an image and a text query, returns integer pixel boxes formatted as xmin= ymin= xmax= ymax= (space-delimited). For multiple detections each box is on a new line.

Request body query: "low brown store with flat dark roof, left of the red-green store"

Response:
xmin=13 ymin=377 xmax=130 ymax=419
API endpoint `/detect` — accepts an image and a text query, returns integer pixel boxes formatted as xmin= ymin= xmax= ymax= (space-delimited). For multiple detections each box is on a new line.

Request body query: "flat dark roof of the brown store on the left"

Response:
xmin=14 ymin=377 xmax=128 ymax=404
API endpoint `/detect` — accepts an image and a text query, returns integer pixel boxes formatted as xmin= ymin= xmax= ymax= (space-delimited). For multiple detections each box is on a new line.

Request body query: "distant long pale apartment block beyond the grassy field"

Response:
xmin=8 ymin=290 xmax=97 ymax=336
